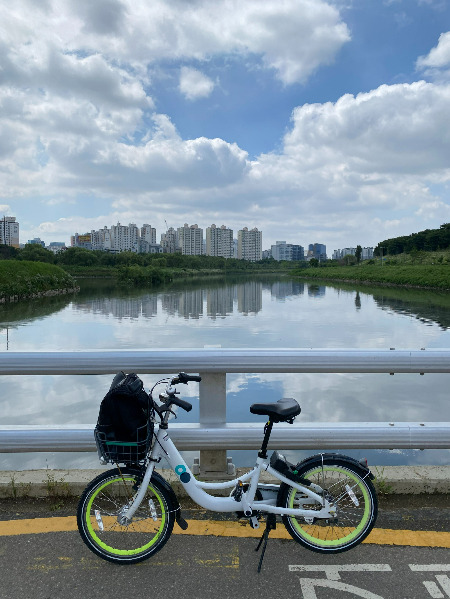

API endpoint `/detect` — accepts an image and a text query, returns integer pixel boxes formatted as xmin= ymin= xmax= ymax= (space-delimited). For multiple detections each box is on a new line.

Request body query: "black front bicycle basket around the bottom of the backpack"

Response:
xmin=94 ymin=422 xmax=153 ymax=464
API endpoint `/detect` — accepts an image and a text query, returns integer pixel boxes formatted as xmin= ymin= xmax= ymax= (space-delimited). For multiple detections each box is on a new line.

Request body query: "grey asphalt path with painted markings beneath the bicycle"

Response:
xmin=0 ymin=497 xmax=450 ymax=599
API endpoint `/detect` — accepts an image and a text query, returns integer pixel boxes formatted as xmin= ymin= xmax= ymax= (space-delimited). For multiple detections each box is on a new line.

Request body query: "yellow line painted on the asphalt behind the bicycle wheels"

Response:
xmin=0 ymin=516 xmax=450 ymax=549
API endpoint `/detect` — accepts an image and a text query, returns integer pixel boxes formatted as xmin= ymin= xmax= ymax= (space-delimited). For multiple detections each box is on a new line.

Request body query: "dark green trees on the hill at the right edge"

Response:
xmin=374 ymin=223 xmax=450 ymax=256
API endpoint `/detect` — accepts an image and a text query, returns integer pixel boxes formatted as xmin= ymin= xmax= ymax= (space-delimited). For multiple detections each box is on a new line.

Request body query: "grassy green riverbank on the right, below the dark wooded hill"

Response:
xmin=291 ymin=264 xmax=450 ymax=291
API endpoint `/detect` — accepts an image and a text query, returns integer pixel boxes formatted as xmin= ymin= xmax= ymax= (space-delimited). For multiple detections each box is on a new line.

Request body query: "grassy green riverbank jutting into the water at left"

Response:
xmin=0 ymin=260 xmax=78 ymax=303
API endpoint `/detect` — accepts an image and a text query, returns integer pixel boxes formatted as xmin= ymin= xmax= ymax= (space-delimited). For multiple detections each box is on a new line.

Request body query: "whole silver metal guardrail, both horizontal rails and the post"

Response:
xmin=0 ymin=348 xmax=450 ymax=470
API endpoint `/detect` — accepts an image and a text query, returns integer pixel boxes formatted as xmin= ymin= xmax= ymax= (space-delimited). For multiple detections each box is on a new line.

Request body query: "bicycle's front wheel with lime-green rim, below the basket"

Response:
xmin=77 ymin=468 xmax=175 ymax=564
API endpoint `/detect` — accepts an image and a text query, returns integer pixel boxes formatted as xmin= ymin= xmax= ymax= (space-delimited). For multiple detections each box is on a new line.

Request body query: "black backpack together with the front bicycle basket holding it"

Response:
xmin=94 ymin=372 xmax=153 ymax=464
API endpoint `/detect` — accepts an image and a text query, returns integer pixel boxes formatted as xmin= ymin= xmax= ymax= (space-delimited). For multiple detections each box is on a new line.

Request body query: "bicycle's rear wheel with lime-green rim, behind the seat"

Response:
xmin=278 ymin=458 xmax=378 ymax=553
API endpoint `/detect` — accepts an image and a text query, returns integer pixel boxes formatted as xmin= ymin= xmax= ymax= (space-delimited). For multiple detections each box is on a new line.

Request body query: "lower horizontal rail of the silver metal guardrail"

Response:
xmin=0 ymin=422 xmax=450 ymax=453
